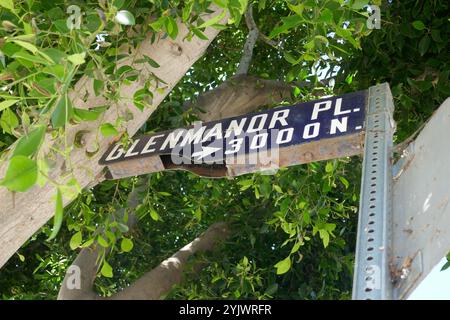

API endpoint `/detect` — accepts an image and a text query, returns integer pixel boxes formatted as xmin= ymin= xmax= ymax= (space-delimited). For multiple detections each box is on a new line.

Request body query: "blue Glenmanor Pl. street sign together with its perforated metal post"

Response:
xmin=99 ymin=83 xmax=395 ymax=299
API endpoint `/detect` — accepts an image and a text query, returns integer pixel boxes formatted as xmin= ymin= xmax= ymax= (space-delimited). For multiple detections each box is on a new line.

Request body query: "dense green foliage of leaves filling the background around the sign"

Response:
xmin=0 ymin=0 xmax=450 ymax=299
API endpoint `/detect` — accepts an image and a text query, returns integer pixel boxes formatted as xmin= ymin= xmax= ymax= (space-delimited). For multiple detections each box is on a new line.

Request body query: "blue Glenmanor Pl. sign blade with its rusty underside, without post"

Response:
xmin=99 ymin=91 xmax=367 ymax=179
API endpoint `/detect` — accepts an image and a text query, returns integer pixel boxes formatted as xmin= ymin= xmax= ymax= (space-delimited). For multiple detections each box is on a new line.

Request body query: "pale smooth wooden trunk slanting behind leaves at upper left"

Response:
xmin=0 ymin=7 xmax=227 ymax=267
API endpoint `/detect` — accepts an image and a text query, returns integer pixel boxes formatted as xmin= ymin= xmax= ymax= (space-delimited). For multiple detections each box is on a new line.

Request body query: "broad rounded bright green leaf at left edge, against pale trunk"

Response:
xmin=0 ymin=156 xmax=38 ymax=192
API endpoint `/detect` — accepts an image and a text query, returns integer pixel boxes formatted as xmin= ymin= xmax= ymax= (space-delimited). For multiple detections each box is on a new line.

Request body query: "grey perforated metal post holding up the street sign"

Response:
xmin=353 ymin=83 xmax=395 ymax=300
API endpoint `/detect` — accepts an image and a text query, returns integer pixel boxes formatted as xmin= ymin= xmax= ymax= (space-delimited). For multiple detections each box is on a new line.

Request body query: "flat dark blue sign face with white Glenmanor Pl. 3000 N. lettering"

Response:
xmin=103 ymin=92 xmax=364 ymax=163
